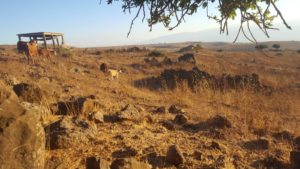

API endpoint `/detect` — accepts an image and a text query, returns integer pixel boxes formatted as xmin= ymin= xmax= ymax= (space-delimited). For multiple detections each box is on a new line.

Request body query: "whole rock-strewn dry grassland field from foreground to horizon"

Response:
xmin=0 ymin=43 xmax=300 ymax=169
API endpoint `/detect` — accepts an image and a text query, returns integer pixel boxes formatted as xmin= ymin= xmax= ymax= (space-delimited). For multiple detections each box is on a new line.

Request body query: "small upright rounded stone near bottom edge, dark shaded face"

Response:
xmin=166 ymin=145 xmax=185 ymax=166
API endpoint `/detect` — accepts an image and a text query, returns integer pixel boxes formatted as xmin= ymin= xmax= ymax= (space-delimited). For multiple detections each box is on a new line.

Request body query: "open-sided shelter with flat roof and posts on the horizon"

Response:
xmin=17 ymin=32 xmax=65 ymax=50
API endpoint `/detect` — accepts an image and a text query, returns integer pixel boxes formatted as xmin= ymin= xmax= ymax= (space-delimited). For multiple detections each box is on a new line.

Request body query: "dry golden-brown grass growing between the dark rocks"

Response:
xmin=0 ymin=43 xmax=300 ymax=166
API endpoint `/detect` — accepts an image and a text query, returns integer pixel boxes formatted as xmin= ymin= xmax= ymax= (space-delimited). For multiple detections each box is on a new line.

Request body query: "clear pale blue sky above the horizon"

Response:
xmin=0 ymin=0 xmax=300 ymax=47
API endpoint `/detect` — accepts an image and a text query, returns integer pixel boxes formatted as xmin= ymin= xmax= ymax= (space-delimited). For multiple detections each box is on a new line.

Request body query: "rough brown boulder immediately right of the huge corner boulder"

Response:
xmin=45 ymin=116 xmax=97 ymax=150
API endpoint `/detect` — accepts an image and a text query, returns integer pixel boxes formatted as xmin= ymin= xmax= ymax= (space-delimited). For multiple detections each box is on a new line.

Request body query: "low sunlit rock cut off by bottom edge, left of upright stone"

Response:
xmin=110 ymin=158 xmax=152 ymax=169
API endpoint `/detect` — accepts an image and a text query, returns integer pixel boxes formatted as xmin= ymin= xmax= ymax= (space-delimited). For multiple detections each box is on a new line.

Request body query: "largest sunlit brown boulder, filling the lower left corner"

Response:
xmin=0 ymin=82 xmax=45 ymax=169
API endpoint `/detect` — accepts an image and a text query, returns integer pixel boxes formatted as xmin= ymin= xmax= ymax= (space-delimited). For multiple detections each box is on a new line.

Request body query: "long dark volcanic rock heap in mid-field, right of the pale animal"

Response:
xmin=135 ymin=67 xmax=273 ymax=95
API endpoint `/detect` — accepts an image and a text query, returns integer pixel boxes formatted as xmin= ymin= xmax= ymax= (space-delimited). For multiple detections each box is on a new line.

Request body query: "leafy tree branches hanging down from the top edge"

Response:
xmin=107 ymin=0 xmax=291 ymax=42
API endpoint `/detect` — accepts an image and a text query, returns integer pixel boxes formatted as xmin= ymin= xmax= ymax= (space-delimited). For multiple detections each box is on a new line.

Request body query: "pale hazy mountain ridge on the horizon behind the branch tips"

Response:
xmin=145 ymin=20 xmax=300 ymax=50
